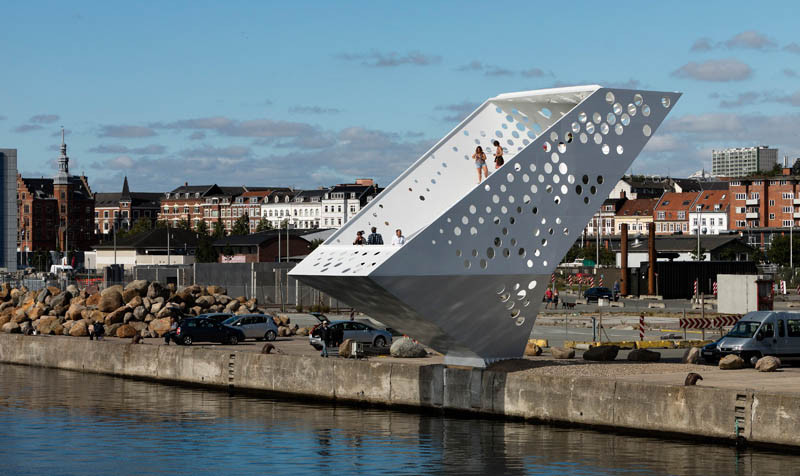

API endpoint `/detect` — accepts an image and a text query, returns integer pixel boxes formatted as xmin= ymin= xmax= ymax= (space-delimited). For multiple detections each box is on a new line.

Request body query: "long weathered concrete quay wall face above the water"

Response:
xmin=0 ymin=334 xmax=800 ymax=446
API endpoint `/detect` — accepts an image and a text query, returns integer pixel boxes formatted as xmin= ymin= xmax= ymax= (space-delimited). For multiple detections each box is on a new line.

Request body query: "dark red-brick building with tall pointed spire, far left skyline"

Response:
xmin=17 ymin=133 xmax=95 ymax=252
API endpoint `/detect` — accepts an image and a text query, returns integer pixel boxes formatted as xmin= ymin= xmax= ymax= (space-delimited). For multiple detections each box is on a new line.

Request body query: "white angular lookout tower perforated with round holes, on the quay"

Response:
xmin=290 ymin=85 xmax=680 ymax=366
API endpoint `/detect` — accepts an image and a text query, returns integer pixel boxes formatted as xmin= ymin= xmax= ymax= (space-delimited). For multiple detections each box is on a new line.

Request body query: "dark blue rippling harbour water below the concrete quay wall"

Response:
xmin=0 ymin=365 xmax=800 ymax=475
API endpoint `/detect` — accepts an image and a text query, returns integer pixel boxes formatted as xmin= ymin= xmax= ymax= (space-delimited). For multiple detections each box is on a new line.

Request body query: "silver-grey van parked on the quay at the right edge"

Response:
xmin=702 ymin=311 xmax=800 ymax=365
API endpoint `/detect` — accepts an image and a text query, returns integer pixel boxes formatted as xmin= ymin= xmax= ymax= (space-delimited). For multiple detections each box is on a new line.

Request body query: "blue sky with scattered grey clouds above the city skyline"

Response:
xmin=0 ymin=1 xmax=800 ymax=191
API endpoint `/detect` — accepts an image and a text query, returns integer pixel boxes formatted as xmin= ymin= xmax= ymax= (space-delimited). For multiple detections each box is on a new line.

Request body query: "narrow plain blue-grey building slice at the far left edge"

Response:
xmin=0 ymin=149 xmax=17 ymax=271
